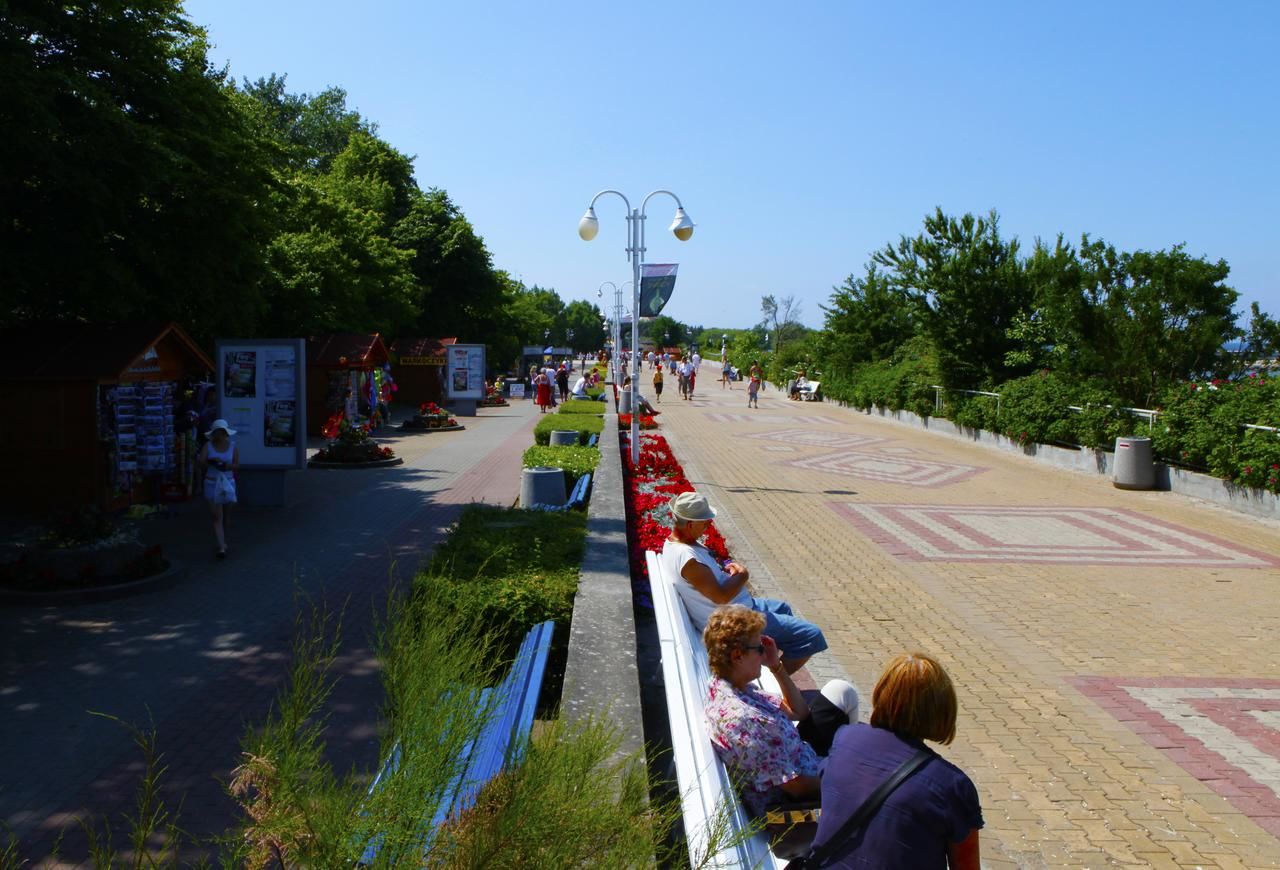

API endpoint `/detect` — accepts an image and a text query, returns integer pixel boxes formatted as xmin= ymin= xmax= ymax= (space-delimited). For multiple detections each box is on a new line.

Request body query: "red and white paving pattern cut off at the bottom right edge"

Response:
xmin=1073 ymin=677 xmax=1280 ymax=837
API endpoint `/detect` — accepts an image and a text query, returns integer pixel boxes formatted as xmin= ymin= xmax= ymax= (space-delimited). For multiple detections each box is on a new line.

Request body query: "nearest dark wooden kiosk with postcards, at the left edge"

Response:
xmin=0 ymin=321 xmax=214 ymax=517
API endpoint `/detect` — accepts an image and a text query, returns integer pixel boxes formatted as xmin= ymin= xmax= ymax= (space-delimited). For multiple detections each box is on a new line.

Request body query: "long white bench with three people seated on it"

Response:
xmin=645 ymin=553 xmax=787 ymax=870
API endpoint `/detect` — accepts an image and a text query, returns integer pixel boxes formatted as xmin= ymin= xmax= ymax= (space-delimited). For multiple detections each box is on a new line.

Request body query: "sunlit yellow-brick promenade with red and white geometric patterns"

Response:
xmin=659 ymin=383 xmax=1280 ymax=867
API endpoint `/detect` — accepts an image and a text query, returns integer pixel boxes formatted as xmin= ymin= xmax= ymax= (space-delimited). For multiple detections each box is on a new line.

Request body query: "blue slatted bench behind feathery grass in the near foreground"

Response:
xmin=358 ymin=621 xmax=556 ymax=866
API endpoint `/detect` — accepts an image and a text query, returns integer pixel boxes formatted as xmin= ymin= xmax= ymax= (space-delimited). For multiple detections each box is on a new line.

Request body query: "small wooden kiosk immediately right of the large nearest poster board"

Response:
xmin=306 ymin=333 xmax=389 ymax=432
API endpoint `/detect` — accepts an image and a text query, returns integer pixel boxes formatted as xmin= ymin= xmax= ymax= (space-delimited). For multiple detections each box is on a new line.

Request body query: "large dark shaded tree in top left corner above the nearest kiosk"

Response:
xmin=0 ymin=0 xmax=273 ymax=340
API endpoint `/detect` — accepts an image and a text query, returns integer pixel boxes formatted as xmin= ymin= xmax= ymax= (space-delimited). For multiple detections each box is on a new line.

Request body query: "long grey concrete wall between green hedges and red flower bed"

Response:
xmin=561 ymin=413 xmax=644 ymax=759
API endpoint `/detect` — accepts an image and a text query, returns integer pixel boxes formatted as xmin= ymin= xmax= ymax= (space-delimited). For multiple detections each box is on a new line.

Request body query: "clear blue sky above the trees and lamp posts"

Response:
xmin=187 ymin=0 xmax=1280 ymax=326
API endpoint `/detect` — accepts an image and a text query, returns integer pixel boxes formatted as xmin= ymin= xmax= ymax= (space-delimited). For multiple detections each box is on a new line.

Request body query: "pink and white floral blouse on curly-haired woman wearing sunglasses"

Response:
xmin=707 ymin=677 xmax=820 ymax=815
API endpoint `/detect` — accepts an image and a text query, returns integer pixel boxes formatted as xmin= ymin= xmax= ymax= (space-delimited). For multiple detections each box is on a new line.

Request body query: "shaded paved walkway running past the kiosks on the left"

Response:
xmin=0 ymin=402 xmax=536 ymax=866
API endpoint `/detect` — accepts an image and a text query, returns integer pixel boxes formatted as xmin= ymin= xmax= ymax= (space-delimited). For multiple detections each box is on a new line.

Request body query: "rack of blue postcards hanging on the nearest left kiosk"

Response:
xmin=100 ymin=381 xmax=179 ymax=494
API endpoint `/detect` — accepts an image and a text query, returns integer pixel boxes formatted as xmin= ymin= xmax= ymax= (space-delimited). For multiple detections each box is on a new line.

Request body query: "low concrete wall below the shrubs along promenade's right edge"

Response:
xmin=826 ymin=399 xmax=1280 ymax=519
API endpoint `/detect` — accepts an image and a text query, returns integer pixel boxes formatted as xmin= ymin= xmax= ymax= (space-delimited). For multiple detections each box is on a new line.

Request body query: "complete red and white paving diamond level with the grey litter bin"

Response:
xmin=831 ymin=502 xmax=1280 ymax=568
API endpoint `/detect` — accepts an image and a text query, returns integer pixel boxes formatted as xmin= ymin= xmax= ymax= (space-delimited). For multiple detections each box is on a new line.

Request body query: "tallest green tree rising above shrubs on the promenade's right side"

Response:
xmin=873 ymin=209 xmax=1032 ymax=389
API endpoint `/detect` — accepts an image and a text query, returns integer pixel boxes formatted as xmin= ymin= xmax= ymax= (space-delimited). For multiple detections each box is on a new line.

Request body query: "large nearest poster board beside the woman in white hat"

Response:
xmin=214 ymin=338 xmax=307 ymax=468
